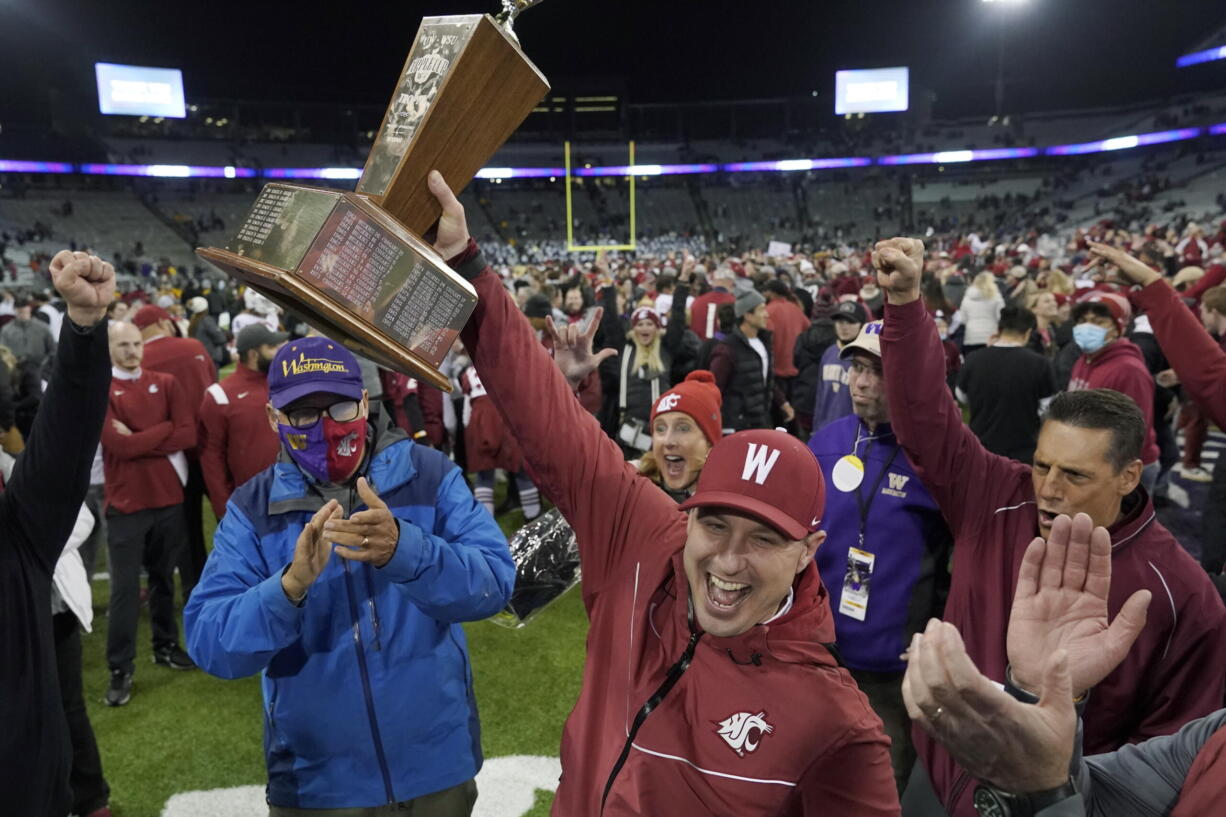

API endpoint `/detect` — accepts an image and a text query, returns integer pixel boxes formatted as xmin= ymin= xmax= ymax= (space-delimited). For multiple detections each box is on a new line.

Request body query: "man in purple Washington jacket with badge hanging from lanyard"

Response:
xmin=809 ymin=321 xmax=950 ymax=795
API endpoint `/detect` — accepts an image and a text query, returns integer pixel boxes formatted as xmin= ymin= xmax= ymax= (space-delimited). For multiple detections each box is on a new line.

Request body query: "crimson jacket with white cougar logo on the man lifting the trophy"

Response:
xmin=454 ymin=244 xmax=899 ymax=817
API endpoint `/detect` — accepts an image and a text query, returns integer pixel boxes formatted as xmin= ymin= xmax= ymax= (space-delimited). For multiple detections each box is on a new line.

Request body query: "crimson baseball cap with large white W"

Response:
xmin=680 ymin=428 xmax=826 ymax=540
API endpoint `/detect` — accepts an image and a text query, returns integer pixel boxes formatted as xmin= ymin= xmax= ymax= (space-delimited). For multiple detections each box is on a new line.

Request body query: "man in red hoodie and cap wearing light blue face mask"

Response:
xmin=1069 ymin=292 xmax=1161 ymax=491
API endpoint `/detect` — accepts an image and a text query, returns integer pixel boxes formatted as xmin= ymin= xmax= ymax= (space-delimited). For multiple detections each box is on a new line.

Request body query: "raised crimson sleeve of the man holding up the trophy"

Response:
xmin=452 ymin=244 xmax=685 ymax=604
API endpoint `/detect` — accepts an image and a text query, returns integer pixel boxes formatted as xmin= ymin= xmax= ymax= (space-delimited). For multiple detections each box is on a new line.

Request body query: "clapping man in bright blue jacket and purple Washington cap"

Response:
xmin=184 ymin=337 xmax=515 ymax=817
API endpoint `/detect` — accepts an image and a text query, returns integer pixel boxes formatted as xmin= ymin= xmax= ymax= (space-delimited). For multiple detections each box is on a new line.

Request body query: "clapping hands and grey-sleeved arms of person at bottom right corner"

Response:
xmin=904 ymin=514 xmax=1226 ymax=817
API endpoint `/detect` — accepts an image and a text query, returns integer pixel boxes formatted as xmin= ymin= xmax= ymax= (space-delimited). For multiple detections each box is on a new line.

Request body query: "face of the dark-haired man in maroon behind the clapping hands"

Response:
xmin=1030 ymin=420 xmax=1141 ymax=539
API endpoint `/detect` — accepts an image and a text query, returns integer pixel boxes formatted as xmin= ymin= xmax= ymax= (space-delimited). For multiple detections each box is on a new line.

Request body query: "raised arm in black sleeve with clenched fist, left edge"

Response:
xmin=0 ymin=250 xmax=115 ymax=574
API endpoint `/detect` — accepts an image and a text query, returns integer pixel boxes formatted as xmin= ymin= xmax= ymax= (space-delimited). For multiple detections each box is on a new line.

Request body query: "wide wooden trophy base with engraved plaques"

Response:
xmin=196 ymin=184 xmax=477 ymax=391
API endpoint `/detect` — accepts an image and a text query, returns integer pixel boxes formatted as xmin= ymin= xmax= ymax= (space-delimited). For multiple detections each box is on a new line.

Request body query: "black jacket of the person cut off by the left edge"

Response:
xmin=0 ymin=318 xmax=110 ymax=817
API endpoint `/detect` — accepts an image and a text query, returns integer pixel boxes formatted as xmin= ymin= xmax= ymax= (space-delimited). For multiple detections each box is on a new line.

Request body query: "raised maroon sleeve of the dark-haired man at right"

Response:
xmin=881 ymin=299 xmax=1034 ymax=536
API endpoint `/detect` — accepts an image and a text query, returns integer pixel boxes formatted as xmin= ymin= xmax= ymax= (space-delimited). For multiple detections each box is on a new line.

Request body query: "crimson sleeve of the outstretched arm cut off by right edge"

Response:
xmin=1133 ymin=279 xmax=1226 ymax=428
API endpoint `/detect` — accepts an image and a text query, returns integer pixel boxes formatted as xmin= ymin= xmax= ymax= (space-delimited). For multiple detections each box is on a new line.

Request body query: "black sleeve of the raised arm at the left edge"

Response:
xmin=0 ymin=316 xmax=110 ymax=571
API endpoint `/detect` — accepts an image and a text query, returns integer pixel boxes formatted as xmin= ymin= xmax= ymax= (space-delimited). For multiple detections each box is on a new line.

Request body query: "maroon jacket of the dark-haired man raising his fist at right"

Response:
xmin=881 ymin=301 xmax=1226 ymax=817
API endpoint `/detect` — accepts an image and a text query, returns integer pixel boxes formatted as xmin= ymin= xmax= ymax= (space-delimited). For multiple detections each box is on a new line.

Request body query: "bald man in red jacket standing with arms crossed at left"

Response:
xmin=102 ymin=323 xmax=196 ymax=707
